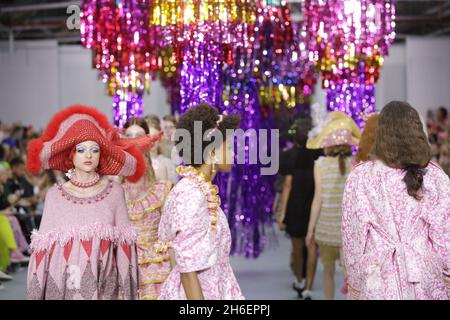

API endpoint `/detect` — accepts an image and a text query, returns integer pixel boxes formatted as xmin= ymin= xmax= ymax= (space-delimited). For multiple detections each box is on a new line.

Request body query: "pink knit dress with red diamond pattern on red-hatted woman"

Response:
xmin=27 ymin=181 xmax=137 ymax=300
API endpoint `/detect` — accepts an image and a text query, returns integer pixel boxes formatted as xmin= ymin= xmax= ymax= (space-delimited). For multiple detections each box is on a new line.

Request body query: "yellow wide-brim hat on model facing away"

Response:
xmin=306 ymin=111 xmax=361 ymax=149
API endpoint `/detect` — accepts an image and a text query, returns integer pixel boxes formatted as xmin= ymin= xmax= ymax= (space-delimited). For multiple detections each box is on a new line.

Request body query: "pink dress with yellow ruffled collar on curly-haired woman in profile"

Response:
xmin=158 ymin=167 xmax=244 ymax=300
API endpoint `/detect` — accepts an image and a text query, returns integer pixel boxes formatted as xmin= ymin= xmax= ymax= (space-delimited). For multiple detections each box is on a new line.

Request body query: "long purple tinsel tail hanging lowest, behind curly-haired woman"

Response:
xmin=216 ymin=79 xmax=275 ymax=258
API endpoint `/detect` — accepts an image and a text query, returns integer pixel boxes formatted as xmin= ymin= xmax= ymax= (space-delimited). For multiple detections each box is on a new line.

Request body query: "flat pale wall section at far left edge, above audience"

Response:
xmin=0 ymin=41 xmax=59 ymax=126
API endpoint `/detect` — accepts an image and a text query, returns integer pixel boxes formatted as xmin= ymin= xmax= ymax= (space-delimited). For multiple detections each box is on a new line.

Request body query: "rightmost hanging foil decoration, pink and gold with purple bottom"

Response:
xmin=302 ymin=0 xmax=395 ymax=127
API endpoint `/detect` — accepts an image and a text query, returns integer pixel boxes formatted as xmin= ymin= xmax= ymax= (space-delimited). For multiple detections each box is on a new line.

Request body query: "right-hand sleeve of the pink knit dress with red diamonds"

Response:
xmin=114 ymin=182 xmax=138 ymax=300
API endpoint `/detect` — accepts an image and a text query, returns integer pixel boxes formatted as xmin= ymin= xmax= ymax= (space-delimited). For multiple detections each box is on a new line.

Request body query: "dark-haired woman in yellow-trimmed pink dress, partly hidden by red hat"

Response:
xmin=123 ymin=117 xmax=172 ymax=300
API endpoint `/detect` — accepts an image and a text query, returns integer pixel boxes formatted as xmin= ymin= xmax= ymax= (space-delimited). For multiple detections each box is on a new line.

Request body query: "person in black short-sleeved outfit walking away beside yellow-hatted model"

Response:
xmin=279 ymin=118 xmax=323 ymax=299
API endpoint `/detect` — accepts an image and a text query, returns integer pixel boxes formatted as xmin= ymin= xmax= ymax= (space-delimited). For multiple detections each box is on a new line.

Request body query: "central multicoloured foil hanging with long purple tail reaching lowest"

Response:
xmin=217 ymin=1 xmax=312 ymax=258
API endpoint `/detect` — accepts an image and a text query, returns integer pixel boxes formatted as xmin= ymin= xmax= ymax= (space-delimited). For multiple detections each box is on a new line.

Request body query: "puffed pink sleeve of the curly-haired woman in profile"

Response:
xmin=159 ymin=184 xmax=217 ymax=273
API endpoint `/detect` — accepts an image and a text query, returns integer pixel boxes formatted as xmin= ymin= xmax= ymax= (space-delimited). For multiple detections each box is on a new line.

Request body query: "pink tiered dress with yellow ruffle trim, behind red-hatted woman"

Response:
xmin=124 ymin=181 xmax=172 ymax=300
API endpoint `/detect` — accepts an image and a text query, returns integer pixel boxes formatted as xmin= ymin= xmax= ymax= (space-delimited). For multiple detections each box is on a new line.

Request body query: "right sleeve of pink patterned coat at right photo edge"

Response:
xmin=427 ymin=168 xmax=450 ymax=298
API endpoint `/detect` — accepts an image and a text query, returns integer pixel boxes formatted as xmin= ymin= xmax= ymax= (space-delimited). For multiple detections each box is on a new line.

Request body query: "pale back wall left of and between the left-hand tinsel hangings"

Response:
xmin=0 ymin=41 xmax=170 ymax=128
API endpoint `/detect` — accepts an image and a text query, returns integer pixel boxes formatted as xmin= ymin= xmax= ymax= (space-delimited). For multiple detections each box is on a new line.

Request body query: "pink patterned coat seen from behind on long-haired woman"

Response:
xmin=342 ymin=161 xmax=450 ymax=300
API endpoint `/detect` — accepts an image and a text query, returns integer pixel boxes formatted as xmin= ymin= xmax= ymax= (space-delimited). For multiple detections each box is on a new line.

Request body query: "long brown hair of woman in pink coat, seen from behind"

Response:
xmin=371 ymin=101 xmax=431 ymax=200
